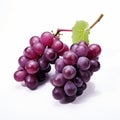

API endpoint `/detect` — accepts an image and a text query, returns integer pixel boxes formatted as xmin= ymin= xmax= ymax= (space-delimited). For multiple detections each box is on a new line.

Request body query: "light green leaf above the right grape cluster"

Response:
xmin=72 ymin=20 xmax=90 ymax=43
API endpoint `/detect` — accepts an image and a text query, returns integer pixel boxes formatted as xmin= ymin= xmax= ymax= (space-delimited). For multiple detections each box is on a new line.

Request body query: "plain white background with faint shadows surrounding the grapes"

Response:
xmin=0 ymin=0 xmax=120 ymax=120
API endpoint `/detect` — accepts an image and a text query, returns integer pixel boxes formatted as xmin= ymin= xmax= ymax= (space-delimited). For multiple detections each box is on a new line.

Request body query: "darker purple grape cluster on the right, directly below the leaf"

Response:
xmin=51 ymin=41 xmax=101 ymax=103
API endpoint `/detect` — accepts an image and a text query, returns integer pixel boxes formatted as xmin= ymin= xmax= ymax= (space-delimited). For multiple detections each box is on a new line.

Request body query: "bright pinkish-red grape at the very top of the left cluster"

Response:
xmin=40 ymin=32 xmax=54 ymax=46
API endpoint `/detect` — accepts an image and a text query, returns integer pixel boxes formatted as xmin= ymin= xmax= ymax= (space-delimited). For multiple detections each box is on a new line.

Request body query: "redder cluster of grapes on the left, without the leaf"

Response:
xmin=14 ymin=32 xmax=68 ymax=90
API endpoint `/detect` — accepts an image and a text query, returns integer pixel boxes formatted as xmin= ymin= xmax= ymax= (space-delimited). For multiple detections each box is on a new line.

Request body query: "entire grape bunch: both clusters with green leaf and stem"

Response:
xmin=14 ymin=14 xmax=103 ymax=103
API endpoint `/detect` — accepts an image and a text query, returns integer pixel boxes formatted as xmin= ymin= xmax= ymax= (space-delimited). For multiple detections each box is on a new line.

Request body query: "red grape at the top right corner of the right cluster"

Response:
xmin=87 ymin=44 xmax=101 ymax=59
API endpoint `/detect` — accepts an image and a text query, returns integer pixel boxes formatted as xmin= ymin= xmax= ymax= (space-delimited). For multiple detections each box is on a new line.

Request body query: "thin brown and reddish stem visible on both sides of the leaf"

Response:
xmin=54 ymin=14 xmax=104 ymax=36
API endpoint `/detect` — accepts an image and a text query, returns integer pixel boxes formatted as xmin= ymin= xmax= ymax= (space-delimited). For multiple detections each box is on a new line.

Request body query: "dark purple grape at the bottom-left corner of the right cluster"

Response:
xmin=52 ymin=87 xmax=65 ymax=100
